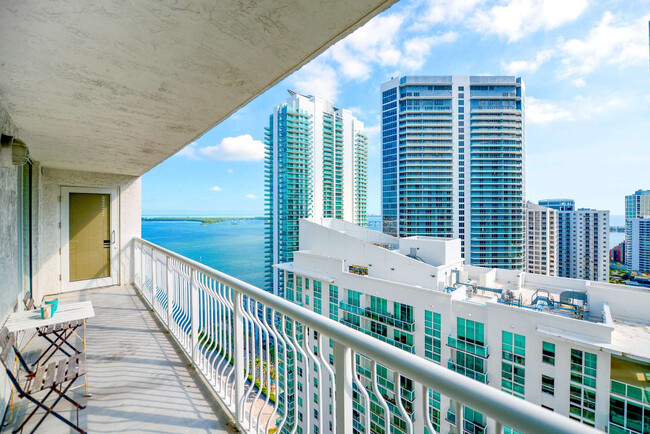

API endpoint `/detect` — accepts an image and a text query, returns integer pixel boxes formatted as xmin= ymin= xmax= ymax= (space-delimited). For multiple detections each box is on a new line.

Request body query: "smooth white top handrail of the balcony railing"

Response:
xmin=133 ymin=237 xmax=598 ymax=434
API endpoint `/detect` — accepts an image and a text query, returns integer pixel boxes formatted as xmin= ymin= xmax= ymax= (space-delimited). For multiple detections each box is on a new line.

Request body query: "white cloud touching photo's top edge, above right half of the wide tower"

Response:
xmin=470 ymin=0 xmax=588 ymax=42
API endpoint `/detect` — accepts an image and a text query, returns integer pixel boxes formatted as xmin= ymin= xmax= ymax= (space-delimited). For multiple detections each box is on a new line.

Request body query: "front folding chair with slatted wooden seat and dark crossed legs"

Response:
xmin=0 ymin=327 xmax=86 ymax=433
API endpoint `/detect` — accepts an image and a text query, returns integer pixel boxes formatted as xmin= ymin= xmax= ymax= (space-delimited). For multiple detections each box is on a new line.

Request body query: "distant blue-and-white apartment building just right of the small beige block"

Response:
xmin=539 ymin=199 xmax=609 ymax=282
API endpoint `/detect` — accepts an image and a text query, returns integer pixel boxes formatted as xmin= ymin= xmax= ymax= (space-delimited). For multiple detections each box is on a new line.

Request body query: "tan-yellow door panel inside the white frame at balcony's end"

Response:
xmin=69 ymin=193 xmax=111 ymax=282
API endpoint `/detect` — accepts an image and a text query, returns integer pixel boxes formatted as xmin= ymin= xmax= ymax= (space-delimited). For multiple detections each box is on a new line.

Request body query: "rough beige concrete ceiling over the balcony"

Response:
xmin=0 ymin=0 xmax=395 ymax=175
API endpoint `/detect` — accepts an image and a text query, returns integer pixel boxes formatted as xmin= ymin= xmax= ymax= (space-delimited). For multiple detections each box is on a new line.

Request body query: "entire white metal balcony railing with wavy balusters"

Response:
xmin=133 ymin=238 xmax=594 ymax=433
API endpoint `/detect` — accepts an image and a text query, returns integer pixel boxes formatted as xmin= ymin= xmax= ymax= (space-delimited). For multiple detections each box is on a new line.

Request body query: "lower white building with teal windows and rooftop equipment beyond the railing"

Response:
xmin=278 ymin=219 xmax=650 ymax=433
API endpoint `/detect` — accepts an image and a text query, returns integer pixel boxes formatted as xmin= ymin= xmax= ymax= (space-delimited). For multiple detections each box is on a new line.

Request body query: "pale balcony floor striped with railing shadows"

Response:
xmin=4 ymin=286 xmax=236 ymax=433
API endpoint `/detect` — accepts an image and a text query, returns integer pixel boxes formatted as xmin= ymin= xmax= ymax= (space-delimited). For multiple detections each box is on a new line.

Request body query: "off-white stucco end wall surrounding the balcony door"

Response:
xmin=33 ymin=168 xmax=141 ymax=300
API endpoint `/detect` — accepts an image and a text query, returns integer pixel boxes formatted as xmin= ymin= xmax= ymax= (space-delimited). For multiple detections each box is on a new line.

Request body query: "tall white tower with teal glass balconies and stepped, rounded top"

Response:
xmin=265 ymin=91 xmax=368 ymax=294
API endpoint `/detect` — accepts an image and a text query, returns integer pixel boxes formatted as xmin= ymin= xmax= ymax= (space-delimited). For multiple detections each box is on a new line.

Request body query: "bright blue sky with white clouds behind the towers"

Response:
xmin=142 ymin=0 xmax=650 ymax=216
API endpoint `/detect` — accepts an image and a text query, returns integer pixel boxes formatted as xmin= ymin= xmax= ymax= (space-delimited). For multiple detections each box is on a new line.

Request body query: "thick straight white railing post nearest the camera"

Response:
xmin=334 ymin=341 xmax=354 ymax=433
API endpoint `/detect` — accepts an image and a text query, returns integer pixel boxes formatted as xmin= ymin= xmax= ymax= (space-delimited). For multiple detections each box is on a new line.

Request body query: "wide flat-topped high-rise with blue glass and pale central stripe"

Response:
xmin=381 ymin=76 xmax=525 ymax=269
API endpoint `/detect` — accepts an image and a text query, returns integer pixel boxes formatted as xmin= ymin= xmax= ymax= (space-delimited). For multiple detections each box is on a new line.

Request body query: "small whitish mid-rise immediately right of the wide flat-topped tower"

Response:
xmin=524 ymin=202 xmax=558 ymax=276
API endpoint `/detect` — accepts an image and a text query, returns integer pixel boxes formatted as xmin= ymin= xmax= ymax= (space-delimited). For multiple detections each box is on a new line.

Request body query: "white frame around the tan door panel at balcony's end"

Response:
xmin=61 ymin=186 xmax=120 ymax=292
